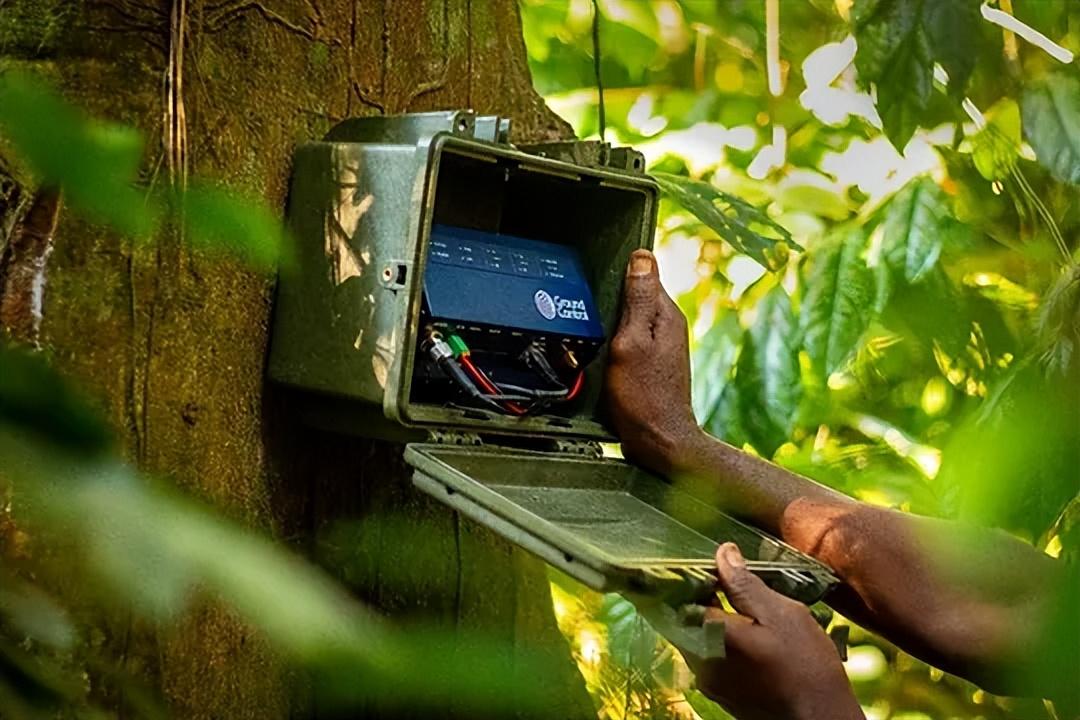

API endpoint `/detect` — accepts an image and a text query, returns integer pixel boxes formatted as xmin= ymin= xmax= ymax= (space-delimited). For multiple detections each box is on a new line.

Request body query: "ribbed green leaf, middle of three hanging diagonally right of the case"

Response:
xmin=800 ymin=229 xmax=874 ymax=385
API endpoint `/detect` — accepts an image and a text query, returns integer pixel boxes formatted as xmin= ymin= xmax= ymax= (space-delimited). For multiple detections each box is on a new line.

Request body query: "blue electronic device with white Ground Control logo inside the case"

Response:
xmin=423 ymin=225 xmax=604 ymax=347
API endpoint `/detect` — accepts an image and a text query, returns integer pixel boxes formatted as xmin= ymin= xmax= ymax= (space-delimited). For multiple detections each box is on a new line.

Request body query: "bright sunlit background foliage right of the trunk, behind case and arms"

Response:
xmin=522 ymin=0 xmax=1080 ymax=720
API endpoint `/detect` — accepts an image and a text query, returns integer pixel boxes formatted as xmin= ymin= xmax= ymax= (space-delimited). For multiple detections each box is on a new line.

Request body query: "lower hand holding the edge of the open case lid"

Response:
xmin=683 ymin=543 xmax=864 ymax=720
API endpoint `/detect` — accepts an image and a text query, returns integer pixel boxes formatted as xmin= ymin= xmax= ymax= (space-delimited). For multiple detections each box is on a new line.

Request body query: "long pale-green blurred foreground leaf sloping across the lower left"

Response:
xmin=0 ymin=351 xmax=553 ymax=712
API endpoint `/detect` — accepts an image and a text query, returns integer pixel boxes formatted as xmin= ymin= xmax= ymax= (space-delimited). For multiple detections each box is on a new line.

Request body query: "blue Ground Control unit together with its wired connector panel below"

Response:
xmin=414 ymin=225 xmax=605 ymax=416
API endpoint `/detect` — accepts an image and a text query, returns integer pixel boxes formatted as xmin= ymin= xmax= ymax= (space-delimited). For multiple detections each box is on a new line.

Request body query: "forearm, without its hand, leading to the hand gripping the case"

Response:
xmin=671 ymin=436 xmax=1059 ymax=685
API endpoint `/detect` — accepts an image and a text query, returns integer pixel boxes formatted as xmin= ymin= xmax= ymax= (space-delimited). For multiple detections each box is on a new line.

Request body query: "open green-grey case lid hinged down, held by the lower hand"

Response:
xmin=405 ymin=444 xmax=837 ymax=603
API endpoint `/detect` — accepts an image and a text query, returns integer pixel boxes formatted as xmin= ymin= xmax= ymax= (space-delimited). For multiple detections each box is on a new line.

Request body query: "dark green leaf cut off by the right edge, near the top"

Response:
xmin=1020 ymin=71 xmax=1080 ymax=182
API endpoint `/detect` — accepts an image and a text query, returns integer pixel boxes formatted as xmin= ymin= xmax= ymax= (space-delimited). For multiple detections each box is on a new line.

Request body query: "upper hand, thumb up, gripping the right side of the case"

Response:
xmin=606 ymin=250 xmax=704 ymax=473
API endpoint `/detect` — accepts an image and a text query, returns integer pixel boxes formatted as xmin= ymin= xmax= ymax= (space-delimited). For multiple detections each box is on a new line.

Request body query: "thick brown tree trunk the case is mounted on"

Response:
xmin=0 ymin=0 xmax=594 ymax=720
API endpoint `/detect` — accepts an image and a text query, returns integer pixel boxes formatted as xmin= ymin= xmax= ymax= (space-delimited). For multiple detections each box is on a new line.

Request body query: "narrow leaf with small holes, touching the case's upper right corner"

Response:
xmin=652 ymin=173 xmax=802 ymax=270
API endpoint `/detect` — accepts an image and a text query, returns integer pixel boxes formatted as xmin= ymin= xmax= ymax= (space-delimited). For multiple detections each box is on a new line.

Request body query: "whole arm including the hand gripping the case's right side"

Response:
xmin=607 ymin=252 xmax=1064 ymax=694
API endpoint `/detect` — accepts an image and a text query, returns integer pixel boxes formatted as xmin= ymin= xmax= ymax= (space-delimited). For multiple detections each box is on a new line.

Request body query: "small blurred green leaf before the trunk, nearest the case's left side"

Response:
xmin=177 ymin=185 xmax=291 ymax=269
